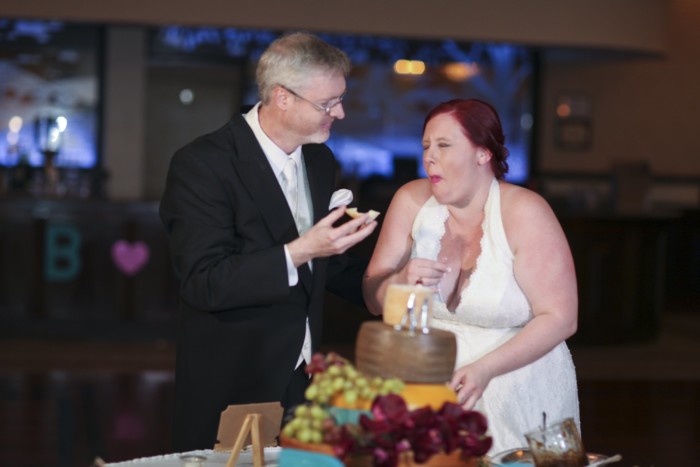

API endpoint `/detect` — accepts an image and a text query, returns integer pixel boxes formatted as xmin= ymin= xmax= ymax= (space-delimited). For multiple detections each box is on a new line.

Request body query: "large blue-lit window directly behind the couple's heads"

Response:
xmin=149 ymin=26 xmax=534 ymax=183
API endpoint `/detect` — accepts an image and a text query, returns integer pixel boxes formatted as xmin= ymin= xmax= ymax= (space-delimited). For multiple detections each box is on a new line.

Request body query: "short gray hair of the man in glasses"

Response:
xmin=255 ymin=32 xmax=350 ymax=104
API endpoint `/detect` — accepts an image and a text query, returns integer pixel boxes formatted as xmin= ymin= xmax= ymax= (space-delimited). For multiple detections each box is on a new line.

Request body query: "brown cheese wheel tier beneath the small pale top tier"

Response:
xmin=355 ymin=321 xmax=457 ymax=384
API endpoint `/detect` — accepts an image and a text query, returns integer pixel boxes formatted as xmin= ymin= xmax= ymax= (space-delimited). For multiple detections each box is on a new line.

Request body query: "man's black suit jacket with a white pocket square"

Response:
xmin=160 ymin=111 xmax=366 ymax=452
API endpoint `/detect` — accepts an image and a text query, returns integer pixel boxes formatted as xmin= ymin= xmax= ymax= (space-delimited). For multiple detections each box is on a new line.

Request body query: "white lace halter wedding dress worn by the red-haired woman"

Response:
xmin=412 ymin=179 xmax=579 ymax=454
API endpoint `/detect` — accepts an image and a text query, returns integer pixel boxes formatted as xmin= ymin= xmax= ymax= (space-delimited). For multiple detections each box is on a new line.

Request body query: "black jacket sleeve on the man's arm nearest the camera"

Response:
xmin=160 ymin=142 xmax=289 ymax=312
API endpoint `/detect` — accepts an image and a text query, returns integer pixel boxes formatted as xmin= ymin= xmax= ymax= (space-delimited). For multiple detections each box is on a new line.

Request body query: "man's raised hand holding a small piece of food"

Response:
xmin=287 ymin=206 xmax=377 ymax=267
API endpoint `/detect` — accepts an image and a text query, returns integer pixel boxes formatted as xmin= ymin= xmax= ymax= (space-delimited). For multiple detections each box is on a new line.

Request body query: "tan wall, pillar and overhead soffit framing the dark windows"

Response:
xmin=5 ymin=0 xmax=700 ymax=203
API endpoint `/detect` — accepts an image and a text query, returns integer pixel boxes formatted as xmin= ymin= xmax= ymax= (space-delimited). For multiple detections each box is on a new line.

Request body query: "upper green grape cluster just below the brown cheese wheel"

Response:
xmin=304 ymin=352 xmax=404 ymax=407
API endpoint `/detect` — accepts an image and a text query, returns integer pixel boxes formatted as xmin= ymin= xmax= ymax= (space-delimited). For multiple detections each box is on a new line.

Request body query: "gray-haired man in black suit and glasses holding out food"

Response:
xmin=160 ymin=33 xmax=376 ymax=451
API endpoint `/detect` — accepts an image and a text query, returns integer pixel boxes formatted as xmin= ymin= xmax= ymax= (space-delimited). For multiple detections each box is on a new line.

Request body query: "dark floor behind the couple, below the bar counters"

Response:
xmin=0 ymin=313 xmax=700 ymax=467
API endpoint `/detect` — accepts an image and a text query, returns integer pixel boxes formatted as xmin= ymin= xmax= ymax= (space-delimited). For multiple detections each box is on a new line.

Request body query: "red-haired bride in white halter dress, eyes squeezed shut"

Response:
xmin=364 ymin=99 xmax=579 ymax=454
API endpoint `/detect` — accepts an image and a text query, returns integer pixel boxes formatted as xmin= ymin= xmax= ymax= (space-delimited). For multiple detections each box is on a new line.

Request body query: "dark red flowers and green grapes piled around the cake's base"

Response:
xmin=282 ymin=354 xmax=492 ymax=467
